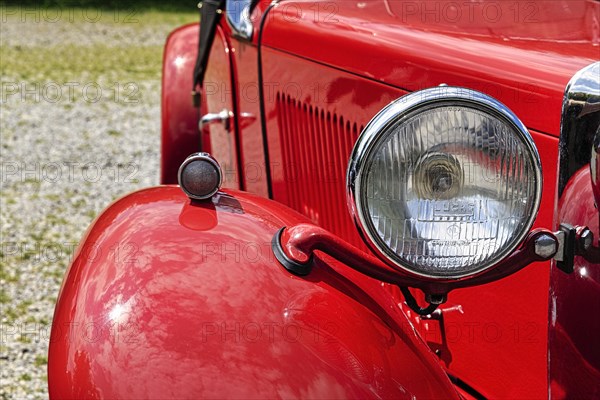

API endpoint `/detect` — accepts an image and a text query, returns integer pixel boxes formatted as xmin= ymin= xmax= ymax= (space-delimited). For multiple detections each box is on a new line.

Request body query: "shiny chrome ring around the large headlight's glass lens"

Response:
xmin=346 ymin=86 xmax=542 ymax=281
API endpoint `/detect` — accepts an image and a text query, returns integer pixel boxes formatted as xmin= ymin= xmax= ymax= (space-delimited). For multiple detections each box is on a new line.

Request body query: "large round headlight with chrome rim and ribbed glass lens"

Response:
xmin=347 ymin=87 xmax=541 ymax=279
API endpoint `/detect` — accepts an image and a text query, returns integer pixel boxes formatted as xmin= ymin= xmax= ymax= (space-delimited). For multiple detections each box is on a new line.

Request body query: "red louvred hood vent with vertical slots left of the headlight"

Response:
xmin=275 ymin=93 xmax=363 ymax=247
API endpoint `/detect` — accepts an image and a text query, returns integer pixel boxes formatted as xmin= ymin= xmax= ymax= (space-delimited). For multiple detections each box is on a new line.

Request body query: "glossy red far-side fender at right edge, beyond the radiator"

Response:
xmin=548 ymin=166 xmax=600 ymax=399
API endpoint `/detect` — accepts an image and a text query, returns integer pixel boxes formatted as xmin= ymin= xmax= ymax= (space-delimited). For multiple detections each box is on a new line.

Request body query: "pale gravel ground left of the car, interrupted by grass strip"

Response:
xmin=0 ymin=9 xmax=195 ymax=399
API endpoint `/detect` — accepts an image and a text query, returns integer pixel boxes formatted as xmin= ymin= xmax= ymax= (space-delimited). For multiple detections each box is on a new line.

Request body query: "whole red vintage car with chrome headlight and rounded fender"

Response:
xmin=48 ymin=0 xmax=600 ymax=399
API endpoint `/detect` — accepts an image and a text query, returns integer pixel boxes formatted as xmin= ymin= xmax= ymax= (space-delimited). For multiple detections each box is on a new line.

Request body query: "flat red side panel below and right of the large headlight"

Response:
xmin=414 ymin=131 xmax=558 ymax=399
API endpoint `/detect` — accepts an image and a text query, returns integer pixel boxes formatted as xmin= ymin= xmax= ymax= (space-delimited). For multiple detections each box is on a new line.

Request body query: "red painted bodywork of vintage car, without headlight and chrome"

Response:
xmin=49 ymin=0 xmax=600 ymax=398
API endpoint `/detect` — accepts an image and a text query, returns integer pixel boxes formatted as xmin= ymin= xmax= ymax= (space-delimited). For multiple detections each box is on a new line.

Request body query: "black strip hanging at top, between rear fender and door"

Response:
xmin=192 ymin=0 xmax=225 ymax=107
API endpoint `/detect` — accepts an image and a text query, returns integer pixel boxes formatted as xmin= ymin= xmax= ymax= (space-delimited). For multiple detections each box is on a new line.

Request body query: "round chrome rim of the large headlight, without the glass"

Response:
xmin=346 ymin=86 xmax=542 ymax=282
